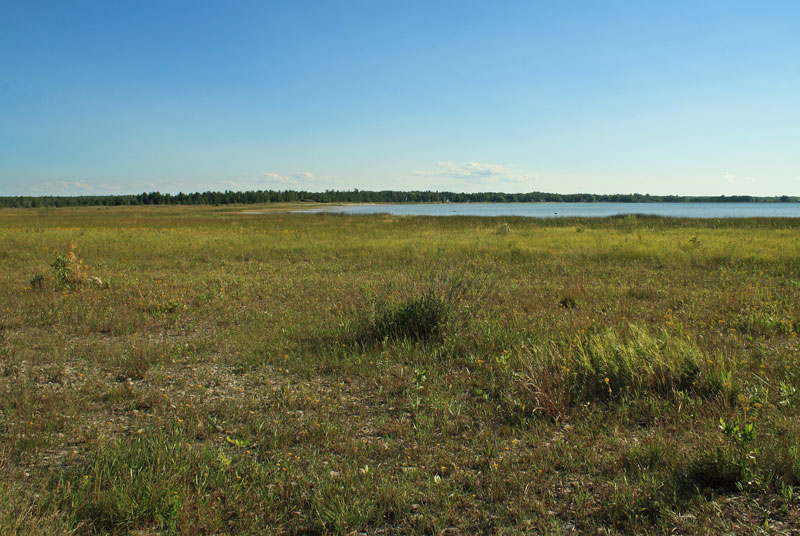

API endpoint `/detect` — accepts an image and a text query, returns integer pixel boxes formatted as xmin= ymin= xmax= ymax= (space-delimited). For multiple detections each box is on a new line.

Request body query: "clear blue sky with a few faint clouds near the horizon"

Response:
xmin=0 ymin=0 xmax=800 ymax=195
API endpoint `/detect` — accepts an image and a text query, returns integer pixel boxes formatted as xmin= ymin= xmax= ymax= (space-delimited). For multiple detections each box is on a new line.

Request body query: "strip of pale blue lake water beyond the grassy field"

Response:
xmin=298 ymin=203 xmax=800 ymax=218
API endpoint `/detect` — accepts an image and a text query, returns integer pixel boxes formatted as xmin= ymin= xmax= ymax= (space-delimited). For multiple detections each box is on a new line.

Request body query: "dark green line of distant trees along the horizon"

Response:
xmin=0 ymin=190 xmax=800 ymax=208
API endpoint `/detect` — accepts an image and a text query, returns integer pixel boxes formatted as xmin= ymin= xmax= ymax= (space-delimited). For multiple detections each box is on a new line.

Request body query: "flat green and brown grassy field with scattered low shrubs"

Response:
xmin=0 ymin=207 xmax=800 ymax=535
